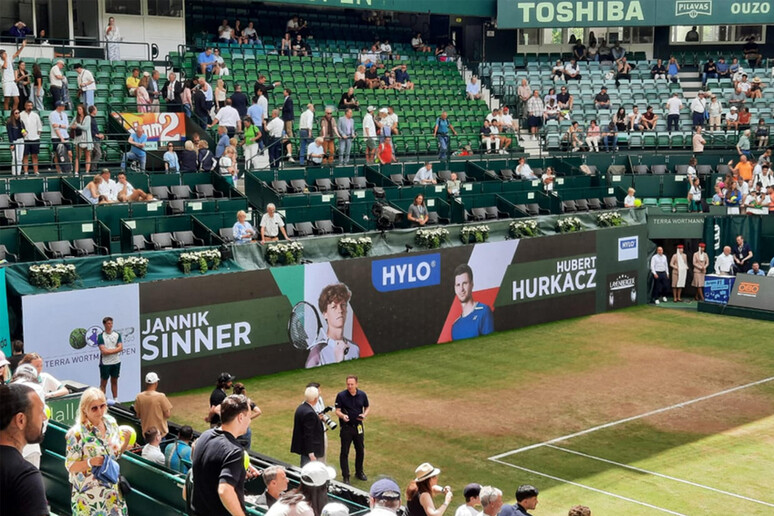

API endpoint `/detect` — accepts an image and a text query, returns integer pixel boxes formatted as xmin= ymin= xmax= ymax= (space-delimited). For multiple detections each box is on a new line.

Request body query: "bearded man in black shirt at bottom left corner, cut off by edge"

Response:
xmin=0 ymin=383 xmax=49 ymax=516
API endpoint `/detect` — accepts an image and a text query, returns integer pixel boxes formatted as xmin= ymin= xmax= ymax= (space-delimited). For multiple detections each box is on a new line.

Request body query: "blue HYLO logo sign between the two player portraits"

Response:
xmin=371 ymin=253 xmax=441 ymax=292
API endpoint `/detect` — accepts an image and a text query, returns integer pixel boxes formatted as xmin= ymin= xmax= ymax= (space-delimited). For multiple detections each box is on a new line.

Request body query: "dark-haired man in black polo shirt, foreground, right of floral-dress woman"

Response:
xmin=191 ymin=394 xmax=258 ymax=516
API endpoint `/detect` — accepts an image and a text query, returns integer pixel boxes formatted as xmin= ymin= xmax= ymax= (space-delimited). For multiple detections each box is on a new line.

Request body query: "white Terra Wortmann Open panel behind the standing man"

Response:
xmin=22 ymin=283 xmax=142 ymax=401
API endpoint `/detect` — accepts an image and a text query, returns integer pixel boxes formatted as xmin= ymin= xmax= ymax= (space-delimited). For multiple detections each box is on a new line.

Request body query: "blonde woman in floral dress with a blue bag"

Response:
xmin=65 ymin=387 xmax=129 ymax=516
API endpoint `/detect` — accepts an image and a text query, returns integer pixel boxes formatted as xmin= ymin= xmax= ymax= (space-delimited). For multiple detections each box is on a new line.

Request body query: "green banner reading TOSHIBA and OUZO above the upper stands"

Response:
xmin=497 ymin=0 xmax=774 ymax=29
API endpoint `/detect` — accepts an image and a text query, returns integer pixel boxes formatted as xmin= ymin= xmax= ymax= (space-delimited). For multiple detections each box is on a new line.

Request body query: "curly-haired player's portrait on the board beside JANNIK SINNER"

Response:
xmin=306 ymin=283 xmax=360 ymax=368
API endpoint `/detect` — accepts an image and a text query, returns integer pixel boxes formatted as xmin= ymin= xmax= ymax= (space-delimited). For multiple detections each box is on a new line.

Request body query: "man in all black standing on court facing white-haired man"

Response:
xmin=336 ymin=375 xmax=371 ymax=484
